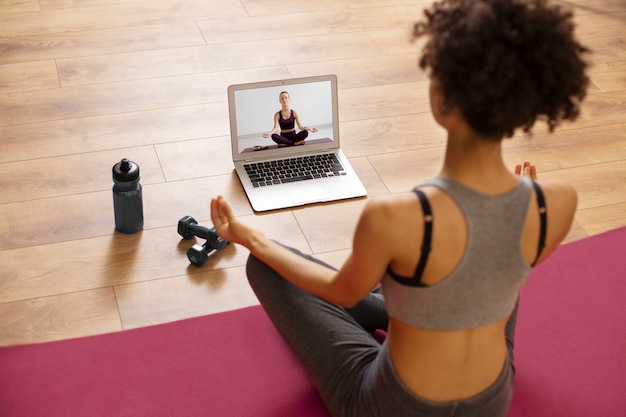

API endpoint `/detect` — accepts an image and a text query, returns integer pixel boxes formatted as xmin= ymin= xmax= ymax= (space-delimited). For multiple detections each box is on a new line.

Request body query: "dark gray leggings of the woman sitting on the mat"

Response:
xmin=247 ymin=249 xmax=517 ymax=417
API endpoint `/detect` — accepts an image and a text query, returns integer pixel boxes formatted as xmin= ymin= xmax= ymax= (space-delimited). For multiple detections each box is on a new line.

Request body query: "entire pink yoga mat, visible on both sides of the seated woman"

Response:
xmin=0 ymin=228 xmax=626 ymax=417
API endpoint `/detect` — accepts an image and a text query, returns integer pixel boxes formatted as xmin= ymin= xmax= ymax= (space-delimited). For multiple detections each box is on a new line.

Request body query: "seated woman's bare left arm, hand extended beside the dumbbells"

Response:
xmin=211 ymin=196 xmax=389 ymax=307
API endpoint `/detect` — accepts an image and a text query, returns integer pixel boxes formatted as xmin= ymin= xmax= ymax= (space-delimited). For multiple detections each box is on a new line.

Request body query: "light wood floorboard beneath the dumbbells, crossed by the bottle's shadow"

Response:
xmin=0 ymin=211 xmax=311 ymax=305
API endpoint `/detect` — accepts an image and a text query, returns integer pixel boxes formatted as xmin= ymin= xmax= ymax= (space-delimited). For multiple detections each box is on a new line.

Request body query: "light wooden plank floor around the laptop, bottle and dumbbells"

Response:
xmin=0 ymin=0 xmax=626 ymax=345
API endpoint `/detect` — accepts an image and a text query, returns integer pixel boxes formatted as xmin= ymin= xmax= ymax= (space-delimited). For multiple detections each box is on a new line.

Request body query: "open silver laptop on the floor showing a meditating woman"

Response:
xmin=228 ymin=75 xmax=367 ymax=211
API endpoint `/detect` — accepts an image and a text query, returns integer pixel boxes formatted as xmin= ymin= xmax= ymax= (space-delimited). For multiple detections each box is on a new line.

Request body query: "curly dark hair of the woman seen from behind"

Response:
xmin=414 ymin=0 xmax=589 ymax=140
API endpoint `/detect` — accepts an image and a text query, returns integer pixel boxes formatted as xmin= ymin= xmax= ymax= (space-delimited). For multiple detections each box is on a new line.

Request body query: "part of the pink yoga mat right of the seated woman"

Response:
xmin=509 ymin=228 xmax=626 ymax=417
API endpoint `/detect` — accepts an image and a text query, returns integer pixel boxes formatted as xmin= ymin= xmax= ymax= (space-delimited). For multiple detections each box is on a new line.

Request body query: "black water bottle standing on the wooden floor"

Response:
xmin=113 ymin=158 xmax=143 ymax=234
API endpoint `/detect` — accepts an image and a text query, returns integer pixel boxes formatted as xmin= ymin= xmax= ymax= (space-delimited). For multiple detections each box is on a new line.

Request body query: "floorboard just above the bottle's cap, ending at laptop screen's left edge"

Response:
xmin=0 ymin=102 xmax=229 ymax=163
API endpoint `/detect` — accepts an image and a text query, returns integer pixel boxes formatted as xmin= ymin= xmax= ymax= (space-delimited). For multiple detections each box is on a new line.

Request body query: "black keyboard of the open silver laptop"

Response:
xmin=244 ymin=153 xmax=346 ymax=187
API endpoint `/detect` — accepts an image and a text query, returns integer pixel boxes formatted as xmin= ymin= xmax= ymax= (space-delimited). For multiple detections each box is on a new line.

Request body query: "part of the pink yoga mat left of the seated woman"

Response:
xmin=0 ymin=306 xmax=328 ymax=417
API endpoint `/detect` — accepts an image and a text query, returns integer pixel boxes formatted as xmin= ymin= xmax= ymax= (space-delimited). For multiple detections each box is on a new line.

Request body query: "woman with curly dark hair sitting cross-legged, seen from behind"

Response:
xmin=211 ymin=0 xmax=588 ymax=417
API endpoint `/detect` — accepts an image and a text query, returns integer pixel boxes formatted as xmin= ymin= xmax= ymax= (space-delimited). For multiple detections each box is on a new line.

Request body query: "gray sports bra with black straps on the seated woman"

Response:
xmin=382 ymin=177 xmax=546 ymax=330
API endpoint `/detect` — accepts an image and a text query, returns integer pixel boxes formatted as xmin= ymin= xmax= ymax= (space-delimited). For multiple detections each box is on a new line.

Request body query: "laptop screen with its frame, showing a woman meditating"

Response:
xmin=228 ymin=75 xmax=339 ymax=160
